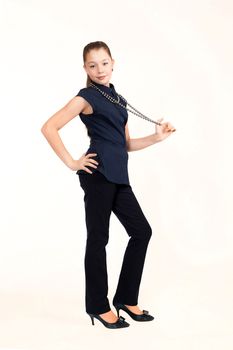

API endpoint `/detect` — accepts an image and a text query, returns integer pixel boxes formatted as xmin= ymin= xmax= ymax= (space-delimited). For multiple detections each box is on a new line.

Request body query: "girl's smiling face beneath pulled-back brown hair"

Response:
xmin=83 ymin=48 xmax=115 ymax=86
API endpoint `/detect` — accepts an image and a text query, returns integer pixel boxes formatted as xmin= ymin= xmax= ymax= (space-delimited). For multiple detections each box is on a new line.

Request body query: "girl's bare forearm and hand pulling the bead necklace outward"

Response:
xmin=125 ymin=118 xmax=176 ymax=152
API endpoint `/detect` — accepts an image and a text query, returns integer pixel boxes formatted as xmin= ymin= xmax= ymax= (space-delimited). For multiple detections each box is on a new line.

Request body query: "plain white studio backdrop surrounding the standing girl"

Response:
xmin=0 ymin=0 xmax=233 ymax=350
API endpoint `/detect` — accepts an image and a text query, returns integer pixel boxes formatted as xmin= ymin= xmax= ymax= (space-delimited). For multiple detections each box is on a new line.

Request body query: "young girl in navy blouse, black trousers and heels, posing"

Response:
xmin=41 ymin=41 xmax=175 ymax=329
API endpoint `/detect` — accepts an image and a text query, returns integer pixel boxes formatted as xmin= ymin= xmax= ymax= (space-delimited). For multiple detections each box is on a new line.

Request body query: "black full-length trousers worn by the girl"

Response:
xmin=79 ymin=171 xmax=152 ymax=314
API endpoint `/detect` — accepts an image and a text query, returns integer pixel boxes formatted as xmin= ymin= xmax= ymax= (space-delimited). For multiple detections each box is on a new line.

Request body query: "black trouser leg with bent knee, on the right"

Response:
xmin=112 ymin=186 xmax=152 ymax=305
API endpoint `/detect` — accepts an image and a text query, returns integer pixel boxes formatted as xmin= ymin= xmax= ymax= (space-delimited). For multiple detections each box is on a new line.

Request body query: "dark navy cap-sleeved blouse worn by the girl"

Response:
xmin=76 ymin=81 xmax=130 ymax=185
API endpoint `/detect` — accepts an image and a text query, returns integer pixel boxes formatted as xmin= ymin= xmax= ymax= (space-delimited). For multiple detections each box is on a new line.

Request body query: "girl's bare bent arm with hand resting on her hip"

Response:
xmin=41 ymin=96 xmax=98 ymax=173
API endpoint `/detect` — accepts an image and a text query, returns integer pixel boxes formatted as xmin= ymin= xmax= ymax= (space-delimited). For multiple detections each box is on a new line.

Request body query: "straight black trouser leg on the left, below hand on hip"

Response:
xmin=79 ymin=172 xmax=116 ymax=314
